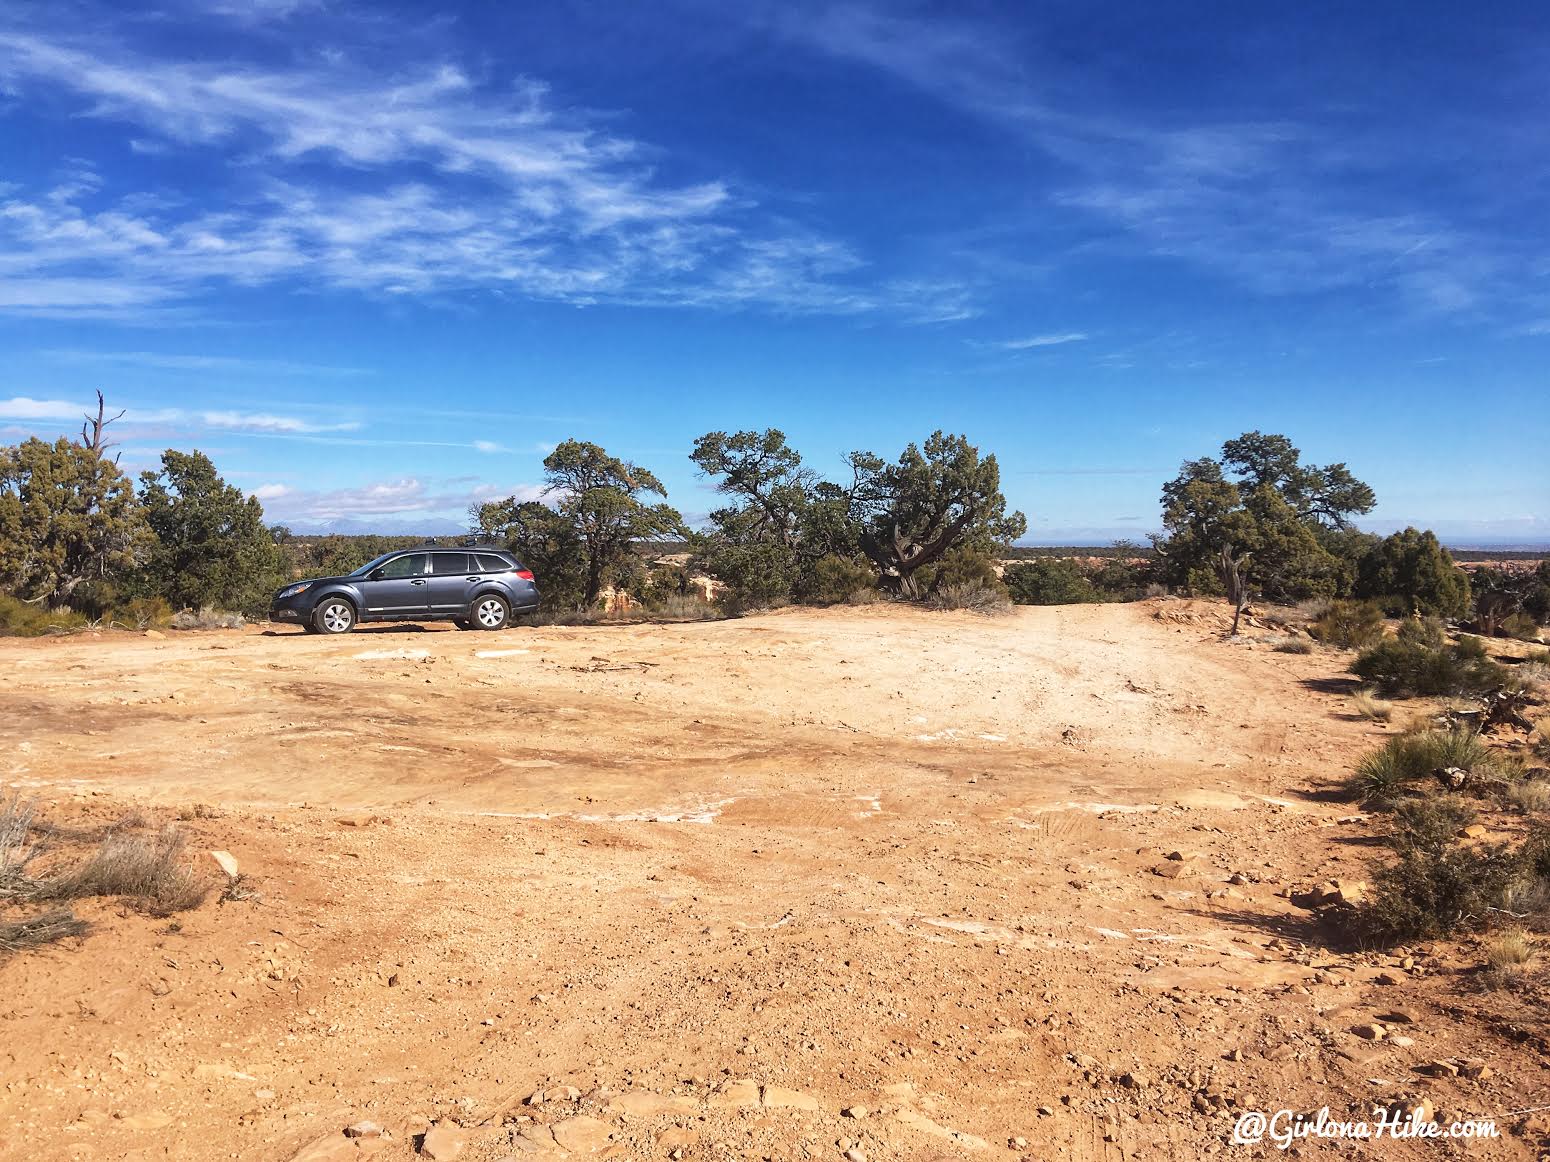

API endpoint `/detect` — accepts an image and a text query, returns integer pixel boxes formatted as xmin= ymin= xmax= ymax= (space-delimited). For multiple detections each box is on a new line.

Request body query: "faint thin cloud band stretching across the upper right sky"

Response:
xmin=775 ymin=0 xmax=1522 ymax=313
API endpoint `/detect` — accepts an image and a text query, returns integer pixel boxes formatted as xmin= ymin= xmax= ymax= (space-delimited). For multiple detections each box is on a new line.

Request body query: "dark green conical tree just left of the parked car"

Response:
xmin=140 ymin=448 xmax=284 ymax=614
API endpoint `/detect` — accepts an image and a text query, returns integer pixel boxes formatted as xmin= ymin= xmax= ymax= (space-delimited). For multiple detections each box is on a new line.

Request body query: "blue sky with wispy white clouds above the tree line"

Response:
xmin=0 ymin=0 xmax=1550 ymax=544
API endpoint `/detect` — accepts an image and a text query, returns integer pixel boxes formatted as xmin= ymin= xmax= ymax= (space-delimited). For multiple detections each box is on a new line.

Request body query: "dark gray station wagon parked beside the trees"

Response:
xmin=270 ymin=545 xmax=538 ymax=634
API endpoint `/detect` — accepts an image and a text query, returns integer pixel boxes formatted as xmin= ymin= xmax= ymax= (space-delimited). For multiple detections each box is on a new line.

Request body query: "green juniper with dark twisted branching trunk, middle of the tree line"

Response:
xmin=848 ymin=431 xmax=1028 ymax=598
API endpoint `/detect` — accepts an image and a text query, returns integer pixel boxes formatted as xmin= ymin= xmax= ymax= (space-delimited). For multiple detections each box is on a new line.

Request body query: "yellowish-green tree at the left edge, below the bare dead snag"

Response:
xmin=0 ymin=438 xmax=149 ymax=607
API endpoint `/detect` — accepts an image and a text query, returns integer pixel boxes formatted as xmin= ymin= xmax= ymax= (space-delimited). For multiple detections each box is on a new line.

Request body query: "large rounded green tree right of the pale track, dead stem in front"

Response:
xmin=1156 ymin=432 xmax=1375 ymax=601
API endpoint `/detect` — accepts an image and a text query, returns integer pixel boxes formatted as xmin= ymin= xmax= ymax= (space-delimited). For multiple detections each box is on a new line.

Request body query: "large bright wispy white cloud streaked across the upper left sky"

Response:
xmin=0 ymin=23 xmax=969 ymax=321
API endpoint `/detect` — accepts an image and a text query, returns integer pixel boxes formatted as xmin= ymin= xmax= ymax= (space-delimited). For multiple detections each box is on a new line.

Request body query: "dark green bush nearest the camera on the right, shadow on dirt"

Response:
xmin=1358 ymin=844 xmax=1530 ymax=944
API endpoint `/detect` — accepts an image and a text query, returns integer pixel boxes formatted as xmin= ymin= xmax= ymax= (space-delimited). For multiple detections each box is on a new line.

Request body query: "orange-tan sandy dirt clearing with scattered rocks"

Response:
xmin=0 ymin=601 xmax=1550 ymax=1162
